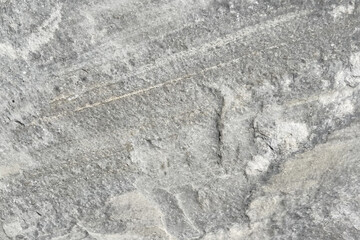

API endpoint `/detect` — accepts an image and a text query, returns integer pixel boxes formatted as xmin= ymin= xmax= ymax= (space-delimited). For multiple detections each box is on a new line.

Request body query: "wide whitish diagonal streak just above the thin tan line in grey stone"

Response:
xmin=52 ymin=11 xmax=310 ymax=102
